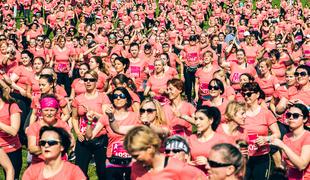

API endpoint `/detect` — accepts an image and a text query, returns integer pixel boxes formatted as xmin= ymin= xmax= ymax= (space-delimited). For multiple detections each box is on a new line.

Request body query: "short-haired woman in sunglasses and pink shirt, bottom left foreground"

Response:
xmin=23 ymin=126 xmax=86 ymax=180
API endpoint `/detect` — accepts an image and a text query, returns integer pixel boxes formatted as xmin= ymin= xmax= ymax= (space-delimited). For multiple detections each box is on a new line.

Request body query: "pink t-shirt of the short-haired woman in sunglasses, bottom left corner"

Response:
xmin=22 ymin=161 xmax=86 ymax=180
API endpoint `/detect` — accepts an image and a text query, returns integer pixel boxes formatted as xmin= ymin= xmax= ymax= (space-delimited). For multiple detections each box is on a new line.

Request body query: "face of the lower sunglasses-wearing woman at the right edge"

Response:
xmin=286 ymin=107 xmax=306 ymax=130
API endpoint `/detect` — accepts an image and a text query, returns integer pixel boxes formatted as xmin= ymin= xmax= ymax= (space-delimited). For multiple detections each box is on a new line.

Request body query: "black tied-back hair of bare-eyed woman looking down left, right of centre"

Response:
xmin=196 ymin=106 xmax=221 ymax=131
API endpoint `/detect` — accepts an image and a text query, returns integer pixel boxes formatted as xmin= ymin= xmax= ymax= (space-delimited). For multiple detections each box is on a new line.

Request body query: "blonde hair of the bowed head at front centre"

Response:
xmin=124 ymin=126 xmax=161 ymax=154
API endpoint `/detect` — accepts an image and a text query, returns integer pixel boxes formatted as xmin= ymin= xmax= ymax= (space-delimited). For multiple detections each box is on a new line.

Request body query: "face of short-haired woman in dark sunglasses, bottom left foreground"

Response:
xmin=40 ymin=131 xmax=64 ymax=160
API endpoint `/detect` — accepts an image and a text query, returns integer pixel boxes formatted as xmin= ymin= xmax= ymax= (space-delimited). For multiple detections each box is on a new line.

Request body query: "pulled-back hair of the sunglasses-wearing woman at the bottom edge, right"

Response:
xmin=212 ymin=143 xmax=245 ymax=178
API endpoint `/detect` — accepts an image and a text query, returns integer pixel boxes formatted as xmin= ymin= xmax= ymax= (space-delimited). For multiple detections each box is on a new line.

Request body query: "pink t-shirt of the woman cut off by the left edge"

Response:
xmin=0 ymin=103 xmax=22 ymax=153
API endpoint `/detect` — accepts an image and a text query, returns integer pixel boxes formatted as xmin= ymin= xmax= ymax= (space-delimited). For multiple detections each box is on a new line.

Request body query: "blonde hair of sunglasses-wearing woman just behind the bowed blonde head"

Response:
xmin=140 ymin=98 xmax=167 ymax=125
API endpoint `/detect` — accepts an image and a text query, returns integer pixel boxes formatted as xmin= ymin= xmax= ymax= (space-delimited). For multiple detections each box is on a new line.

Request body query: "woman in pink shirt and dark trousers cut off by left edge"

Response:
xmin=0 ymin=86 xmax=22 ymax=179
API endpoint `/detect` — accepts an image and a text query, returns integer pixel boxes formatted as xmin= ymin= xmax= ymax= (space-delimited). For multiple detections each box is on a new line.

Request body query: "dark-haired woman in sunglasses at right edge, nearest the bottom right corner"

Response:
xmin=271 ymin=104 xmax=310 ymax=180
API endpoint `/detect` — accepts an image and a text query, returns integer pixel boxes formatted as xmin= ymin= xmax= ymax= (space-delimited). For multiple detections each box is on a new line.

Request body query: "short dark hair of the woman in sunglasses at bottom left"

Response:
xmin=39 ymin=126 xmax=71 ymax=156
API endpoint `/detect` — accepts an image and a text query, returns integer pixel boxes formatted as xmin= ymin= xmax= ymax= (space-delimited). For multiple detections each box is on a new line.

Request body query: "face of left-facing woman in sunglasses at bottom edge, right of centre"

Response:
xmin=205 ymin=150 xmax=229 ymax=180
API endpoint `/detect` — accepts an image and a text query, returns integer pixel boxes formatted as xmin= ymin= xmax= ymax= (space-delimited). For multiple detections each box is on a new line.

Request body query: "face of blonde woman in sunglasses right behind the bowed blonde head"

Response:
xmin=140 ymin=102 xmax=156 ymax=123
